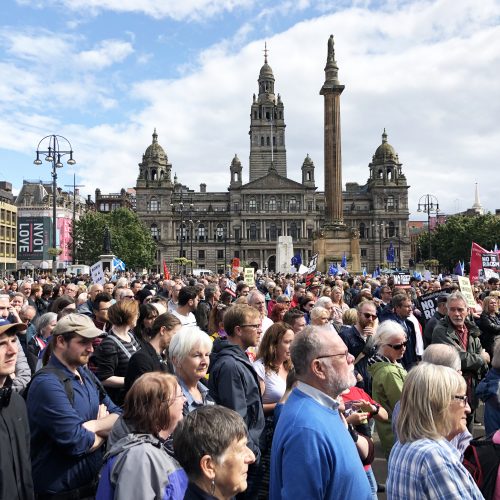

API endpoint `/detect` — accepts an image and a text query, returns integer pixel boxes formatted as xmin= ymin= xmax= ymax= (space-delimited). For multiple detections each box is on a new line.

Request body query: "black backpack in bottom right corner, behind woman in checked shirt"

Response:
xmin=463 ymin=434 xmax=500 ymax=500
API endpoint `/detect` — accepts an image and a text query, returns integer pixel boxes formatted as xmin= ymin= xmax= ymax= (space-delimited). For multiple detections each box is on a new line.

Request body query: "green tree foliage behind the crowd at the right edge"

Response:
xmin=418 ymin=214 xmax=500 ymax=272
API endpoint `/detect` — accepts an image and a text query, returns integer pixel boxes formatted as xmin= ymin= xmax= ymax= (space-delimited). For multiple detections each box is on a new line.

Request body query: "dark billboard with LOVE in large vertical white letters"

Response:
xmin=17 ymin=217 xmax=51 ymax=261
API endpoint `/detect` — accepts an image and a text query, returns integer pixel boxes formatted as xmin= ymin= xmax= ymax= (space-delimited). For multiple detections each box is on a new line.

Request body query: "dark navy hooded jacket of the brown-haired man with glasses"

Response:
xmin=208 ymin=339 xmax=265 ymax=458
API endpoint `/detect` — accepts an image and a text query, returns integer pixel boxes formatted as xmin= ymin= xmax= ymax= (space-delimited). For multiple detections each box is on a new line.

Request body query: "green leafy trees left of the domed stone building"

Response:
xmin=74 ymin=208 xmax=156 ymax=269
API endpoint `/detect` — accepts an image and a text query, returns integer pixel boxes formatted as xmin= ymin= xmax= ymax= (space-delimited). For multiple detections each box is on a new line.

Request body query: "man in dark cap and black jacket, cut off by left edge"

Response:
xmin=0 ymin=320 xmax=33 ymax=500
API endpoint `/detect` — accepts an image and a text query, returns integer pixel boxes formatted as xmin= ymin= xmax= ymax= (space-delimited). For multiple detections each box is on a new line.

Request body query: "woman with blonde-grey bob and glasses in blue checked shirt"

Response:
xmin=387 ymin=362 xmax=483 ymax=500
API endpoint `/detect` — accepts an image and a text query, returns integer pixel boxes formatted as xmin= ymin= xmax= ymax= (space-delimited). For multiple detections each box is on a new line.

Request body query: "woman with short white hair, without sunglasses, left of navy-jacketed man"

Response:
xmin=168 ymin=326 xmax=215 ymax=415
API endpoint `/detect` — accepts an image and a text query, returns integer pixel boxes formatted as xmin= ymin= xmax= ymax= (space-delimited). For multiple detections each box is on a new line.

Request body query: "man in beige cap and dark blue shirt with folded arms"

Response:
xmin=27 ymin=313 xmax=121 ymax=500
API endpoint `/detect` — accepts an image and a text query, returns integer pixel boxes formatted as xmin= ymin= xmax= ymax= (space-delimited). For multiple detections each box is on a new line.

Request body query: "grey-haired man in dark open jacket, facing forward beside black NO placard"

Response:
xmin=432 ymin=292 xmax=490 ymax=430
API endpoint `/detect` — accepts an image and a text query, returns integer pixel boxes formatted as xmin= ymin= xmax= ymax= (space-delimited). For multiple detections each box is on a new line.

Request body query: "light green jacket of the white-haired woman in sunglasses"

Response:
xmin=368 ymin=361 xmax=406 ymax=458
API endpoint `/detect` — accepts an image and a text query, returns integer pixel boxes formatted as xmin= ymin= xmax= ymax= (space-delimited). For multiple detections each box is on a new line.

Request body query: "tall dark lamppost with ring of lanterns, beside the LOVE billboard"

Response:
xmin=33 ymin=134 xmax=76 ymax=276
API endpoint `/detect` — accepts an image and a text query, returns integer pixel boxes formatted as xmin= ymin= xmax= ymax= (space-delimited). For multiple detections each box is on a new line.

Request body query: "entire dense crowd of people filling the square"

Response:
xmin=0 ymin=273 xmax=500 ymax=500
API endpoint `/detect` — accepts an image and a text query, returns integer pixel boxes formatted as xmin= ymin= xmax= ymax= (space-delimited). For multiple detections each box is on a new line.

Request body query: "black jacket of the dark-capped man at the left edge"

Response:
xmin=0 ymin=377 xmax=33 ymax=500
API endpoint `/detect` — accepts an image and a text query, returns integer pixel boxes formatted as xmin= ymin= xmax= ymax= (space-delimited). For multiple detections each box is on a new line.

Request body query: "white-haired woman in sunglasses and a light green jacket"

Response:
xmin=368 ymin=320 xmax=407 ymax=458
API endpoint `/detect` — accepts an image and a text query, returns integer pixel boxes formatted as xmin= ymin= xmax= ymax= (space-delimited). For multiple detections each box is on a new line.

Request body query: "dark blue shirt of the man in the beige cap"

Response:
xmin=27 ymin=356 xmax=121 ymax=493
